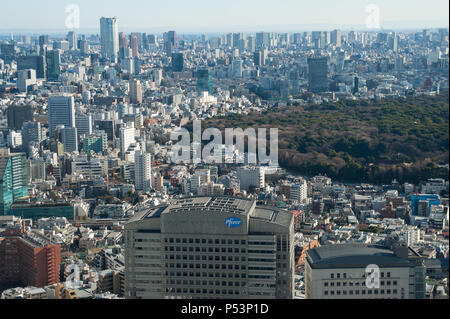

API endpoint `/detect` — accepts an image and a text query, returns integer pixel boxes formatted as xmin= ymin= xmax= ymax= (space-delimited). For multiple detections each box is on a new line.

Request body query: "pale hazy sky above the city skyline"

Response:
xmin=0 ymin=0 xmax=449 ymax=32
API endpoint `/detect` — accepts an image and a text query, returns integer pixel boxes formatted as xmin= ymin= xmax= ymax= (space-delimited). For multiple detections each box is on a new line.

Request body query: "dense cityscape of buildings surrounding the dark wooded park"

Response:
xmin=0 ymin=6 xmax=449 ymax=299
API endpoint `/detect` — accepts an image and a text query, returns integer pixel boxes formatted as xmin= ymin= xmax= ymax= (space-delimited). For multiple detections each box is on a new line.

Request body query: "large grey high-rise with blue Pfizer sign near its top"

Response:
xmin=124 ymin=197 xmax=295 ymax=299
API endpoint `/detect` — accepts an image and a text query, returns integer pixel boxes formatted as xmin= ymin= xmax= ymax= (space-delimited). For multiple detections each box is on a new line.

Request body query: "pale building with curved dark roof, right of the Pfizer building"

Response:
xmin=305 ymin=243 xmax=426 ymax=299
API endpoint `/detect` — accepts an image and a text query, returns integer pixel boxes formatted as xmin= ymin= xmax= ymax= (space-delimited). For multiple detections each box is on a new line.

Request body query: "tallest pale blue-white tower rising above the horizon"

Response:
xmin=100 ymin=17 xmax=119 ymax=61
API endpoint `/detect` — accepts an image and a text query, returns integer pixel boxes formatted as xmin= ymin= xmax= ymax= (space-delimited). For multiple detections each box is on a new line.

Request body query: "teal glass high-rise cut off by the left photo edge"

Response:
xmin=0 ymin=148 xmax=28 ymax=216
